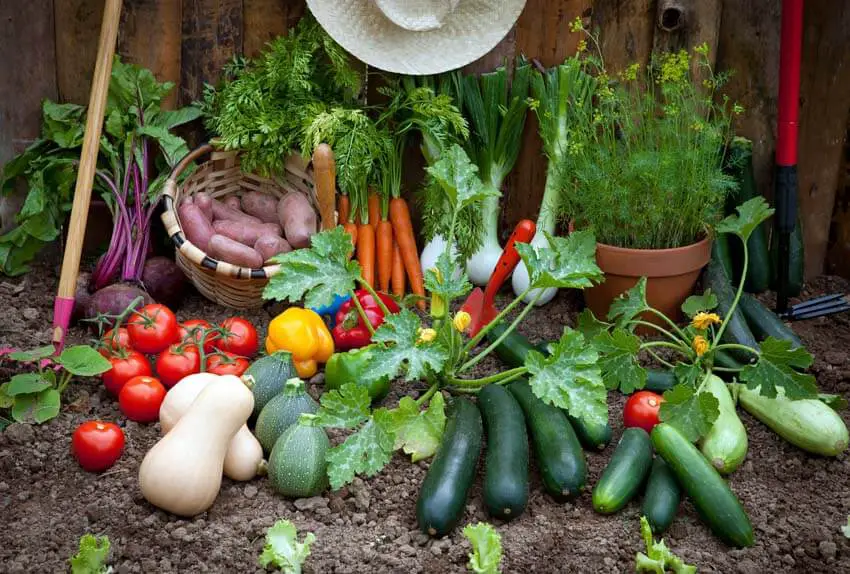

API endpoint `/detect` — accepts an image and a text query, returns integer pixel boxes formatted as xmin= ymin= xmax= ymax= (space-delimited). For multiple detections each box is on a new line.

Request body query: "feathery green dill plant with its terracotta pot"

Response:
xmin=560 ymin=22 xmax=741 ymax=319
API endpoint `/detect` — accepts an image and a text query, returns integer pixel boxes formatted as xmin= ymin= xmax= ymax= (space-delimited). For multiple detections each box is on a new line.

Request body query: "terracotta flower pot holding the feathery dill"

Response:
xmin=584 ymin=237 xmax=711 ymax=323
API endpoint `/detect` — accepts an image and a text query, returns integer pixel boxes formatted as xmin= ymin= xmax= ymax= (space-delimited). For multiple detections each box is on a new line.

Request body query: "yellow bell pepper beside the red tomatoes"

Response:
xmin=266 ymin=307 xmax=334 ymax=379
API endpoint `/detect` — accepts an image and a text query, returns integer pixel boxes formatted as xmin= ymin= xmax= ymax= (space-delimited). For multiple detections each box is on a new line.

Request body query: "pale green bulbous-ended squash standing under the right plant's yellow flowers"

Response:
xmin=700 ymin=375 xmax=747 ymax=474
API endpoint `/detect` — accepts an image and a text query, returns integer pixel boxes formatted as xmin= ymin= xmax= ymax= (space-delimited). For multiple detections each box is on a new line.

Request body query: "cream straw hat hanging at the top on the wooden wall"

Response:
xmin=307 ymin=0 xmax=525 ymax=75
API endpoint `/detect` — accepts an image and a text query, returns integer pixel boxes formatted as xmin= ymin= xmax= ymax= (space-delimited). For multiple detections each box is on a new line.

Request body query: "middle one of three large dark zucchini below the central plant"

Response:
xmin=478 ymin=385 xmax=528 ymax=520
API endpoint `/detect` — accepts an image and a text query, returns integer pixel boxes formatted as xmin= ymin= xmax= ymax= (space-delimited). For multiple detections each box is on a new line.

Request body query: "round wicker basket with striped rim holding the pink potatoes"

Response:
xmin=162 ymin=144 xmax=318 ymax=309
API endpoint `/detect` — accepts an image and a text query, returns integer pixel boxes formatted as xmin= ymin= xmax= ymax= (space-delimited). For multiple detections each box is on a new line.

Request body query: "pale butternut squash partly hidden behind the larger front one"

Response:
xmin=159 ymin=373 xmax=266 ymax=481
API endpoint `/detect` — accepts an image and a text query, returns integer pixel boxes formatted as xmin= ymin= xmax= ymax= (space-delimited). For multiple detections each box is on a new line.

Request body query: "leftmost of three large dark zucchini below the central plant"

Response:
xmin=416 ymin=398 xmax=483 ymax=536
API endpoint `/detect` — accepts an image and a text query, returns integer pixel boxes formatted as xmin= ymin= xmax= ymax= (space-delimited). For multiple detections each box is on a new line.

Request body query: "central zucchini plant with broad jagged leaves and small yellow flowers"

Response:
xmin=264 ymin=145 xmax=608 ymax=489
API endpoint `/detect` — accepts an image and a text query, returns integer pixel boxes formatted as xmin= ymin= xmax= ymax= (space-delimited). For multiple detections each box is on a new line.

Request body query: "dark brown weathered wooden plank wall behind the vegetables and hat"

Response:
xmin=0 ymin=0 xmax=850 ymax=277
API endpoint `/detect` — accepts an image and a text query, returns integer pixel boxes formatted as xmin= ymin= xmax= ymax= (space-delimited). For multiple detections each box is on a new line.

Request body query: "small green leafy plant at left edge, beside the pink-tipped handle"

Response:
xmin=0 ymin=345 xmax=112 ymax=424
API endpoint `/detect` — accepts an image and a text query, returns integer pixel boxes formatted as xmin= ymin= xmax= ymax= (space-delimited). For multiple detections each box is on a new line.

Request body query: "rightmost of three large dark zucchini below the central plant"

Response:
xmin=508 ymin=379 xmax=587 ymax=502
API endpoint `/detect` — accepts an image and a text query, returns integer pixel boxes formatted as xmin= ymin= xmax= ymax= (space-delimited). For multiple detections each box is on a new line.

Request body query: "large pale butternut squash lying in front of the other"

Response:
xmin=139 ymin=377 xmax=254 ymax=517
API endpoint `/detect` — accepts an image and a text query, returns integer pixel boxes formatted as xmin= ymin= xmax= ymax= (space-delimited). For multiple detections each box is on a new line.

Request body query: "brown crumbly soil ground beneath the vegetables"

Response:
xmin=0 ymin=249 xmax=850 ymax=574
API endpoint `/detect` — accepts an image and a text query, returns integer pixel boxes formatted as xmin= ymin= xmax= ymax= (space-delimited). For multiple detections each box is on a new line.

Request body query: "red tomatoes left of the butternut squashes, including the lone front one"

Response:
xmin=72 ymin=304 xmax=259 ymax=472
